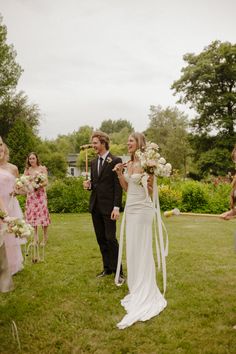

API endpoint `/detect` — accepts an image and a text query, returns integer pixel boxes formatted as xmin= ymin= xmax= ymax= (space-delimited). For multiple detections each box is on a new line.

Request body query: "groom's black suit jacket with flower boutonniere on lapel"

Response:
xmin=89 ymin=153 xmax=122 ymax=214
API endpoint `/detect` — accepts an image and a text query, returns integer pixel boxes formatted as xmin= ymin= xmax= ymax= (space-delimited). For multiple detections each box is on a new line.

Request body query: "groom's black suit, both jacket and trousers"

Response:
xmin=89 ymin=153 xmax=122 ymax=273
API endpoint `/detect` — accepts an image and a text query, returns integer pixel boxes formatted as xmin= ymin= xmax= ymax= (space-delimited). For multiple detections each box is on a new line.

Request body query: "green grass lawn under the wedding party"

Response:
xmin=0 ymin=214 xmax=236 ymax=354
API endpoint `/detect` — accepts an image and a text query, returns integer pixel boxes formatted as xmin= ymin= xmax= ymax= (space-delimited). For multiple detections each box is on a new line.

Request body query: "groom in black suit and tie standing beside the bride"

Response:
xmin=84 ymin=131 xmax=124 ymax=285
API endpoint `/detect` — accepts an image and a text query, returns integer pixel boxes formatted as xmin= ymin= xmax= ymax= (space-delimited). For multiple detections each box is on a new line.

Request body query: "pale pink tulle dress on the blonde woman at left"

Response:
xmin=0 ymin=168 xmax=23 ymax=275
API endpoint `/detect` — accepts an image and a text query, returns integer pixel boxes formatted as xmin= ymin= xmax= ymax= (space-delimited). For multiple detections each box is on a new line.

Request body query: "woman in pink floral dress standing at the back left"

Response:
xmin=24 ymin=152 xmax=50 ymax=245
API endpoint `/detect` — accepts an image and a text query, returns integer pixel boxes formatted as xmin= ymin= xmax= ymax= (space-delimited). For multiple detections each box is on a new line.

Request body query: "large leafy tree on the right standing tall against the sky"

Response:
xmin=172 ymin=41 xmax=236 ymax=150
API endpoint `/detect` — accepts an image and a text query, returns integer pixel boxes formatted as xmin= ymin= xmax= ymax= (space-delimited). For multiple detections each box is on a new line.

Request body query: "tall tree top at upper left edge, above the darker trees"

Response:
xmin=0 ymin=15 xmax=22 ymax=100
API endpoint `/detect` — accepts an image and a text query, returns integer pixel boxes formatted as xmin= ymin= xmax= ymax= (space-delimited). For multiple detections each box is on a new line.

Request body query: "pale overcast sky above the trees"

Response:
xmin=0 ymin=0 xmax=236 ymax=138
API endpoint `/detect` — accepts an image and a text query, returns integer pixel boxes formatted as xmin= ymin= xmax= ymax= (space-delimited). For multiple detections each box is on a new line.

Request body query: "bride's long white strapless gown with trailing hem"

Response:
xmin=117 ymin=174 xmax=167 ymax=329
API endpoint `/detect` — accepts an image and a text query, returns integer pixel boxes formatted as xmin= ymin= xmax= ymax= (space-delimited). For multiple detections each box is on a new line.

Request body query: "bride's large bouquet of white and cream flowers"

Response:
xmin=135 ymin=142 xmax=172 ymax=177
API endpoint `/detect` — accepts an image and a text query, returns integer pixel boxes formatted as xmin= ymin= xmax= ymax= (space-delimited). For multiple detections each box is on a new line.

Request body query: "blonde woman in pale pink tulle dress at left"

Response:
xmin=0 ymin=137 xmax=23 ymax=275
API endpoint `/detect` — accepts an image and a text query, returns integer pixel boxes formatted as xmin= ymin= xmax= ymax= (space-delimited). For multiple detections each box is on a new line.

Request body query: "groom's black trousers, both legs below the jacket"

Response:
xmin=92 ymin=204 xmax=122 ymax=273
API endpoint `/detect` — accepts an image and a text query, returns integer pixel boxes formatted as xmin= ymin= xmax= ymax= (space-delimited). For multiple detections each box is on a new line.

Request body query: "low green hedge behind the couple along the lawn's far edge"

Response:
xmin=18 ymin=177 xmax=231 ymax=214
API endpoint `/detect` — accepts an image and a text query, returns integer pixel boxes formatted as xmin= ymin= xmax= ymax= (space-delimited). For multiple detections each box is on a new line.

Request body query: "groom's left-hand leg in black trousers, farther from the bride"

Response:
xmin=92 ymin=210 xmax=111 ymax=273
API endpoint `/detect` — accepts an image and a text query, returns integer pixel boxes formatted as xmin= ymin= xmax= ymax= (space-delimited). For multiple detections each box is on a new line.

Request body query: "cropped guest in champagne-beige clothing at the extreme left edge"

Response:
xmin=0 ymin=198 xmax=14 ymax=293
